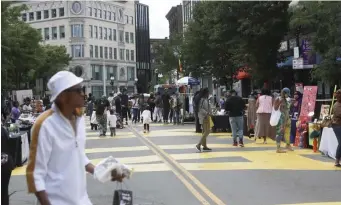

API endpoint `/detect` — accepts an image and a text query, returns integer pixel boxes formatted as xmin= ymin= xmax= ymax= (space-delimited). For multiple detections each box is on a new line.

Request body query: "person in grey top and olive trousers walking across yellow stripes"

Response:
xmin=195 ymin=88 xmax=212 ymax=152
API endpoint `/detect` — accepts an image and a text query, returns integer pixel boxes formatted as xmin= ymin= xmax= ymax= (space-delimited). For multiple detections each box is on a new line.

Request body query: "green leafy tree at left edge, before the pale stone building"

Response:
xmin=1 ymin=1 xmax=70 ymax=90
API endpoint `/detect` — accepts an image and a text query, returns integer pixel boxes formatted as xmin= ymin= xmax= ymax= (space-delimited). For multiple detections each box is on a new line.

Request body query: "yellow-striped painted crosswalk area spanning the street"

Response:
xmin=13 ymin=117 xmax=334 ymax=176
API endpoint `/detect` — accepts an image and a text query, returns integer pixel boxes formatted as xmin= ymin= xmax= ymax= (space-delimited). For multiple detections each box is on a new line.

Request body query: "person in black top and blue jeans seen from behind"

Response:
xmin=225 ymin=90 xmax=246 ymax=147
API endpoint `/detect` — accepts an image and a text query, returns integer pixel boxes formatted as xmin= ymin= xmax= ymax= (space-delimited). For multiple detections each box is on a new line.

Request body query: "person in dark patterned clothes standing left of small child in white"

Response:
xmin=96 ymin=95 xmax=110 ymax=137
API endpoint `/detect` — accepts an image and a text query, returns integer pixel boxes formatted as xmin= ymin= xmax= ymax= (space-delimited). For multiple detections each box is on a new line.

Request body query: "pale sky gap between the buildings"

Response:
xmin=140 ymin=0 xmax=182 ymax=38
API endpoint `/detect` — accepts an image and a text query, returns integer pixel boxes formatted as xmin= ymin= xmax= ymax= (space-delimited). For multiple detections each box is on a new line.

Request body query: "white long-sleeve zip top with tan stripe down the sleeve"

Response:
xmin=26 ymin=105 xmax=91 ymax=205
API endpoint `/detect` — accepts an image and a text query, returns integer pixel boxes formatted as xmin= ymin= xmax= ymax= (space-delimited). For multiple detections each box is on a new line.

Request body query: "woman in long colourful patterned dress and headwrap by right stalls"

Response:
xmin=274 ymin=88 xmax=293 ymax=153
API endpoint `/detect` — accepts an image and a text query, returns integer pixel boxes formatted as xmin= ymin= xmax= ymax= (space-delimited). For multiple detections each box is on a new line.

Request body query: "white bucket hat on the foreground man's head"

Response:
xmin=47 ymin=71 xmax=83 ymax=102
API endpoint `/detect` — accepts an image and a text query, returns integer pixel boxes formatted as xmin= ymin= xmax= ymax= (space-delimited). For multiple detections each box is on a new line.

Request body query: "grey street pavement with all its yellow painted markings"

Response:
xmin=10 ymin=120 xmax=341 ymax=205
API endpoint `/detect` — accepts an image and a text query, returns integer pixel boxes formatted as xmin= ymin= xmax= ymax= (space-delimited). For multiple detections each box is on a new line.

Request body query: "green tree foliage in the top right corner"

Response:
xmin=290 ymin=1 xmax=341 ymax=85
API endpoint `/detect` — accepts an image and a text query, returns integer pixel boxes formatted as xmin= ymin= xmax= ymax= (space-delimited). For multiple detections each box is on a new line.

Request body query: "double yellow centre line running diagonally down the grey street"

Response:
xmin=130 ymin=127 xmax=225 ymax=205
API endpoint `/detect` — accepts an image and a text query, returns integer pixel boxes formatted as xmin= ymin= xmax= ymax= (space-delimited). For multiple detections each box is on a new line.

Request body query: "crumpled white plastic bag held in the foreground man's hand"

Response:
xmin=94 ymin=156 xmax=133 ymax=183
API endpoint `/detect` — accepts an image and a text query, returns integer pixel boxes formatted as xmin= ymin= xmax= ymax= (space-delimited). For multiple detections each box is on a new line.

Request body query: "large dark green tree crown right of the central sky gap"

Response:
xmin=183 ymin=1 xmax=290 ymax=84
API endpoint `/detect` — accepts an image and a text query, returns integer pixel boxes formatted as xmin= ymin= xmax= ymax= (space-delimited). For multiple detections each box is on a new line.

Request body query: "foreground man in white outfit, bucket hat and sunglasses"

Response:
xmin=26 ymin=71 xmax=123 ymax=205
